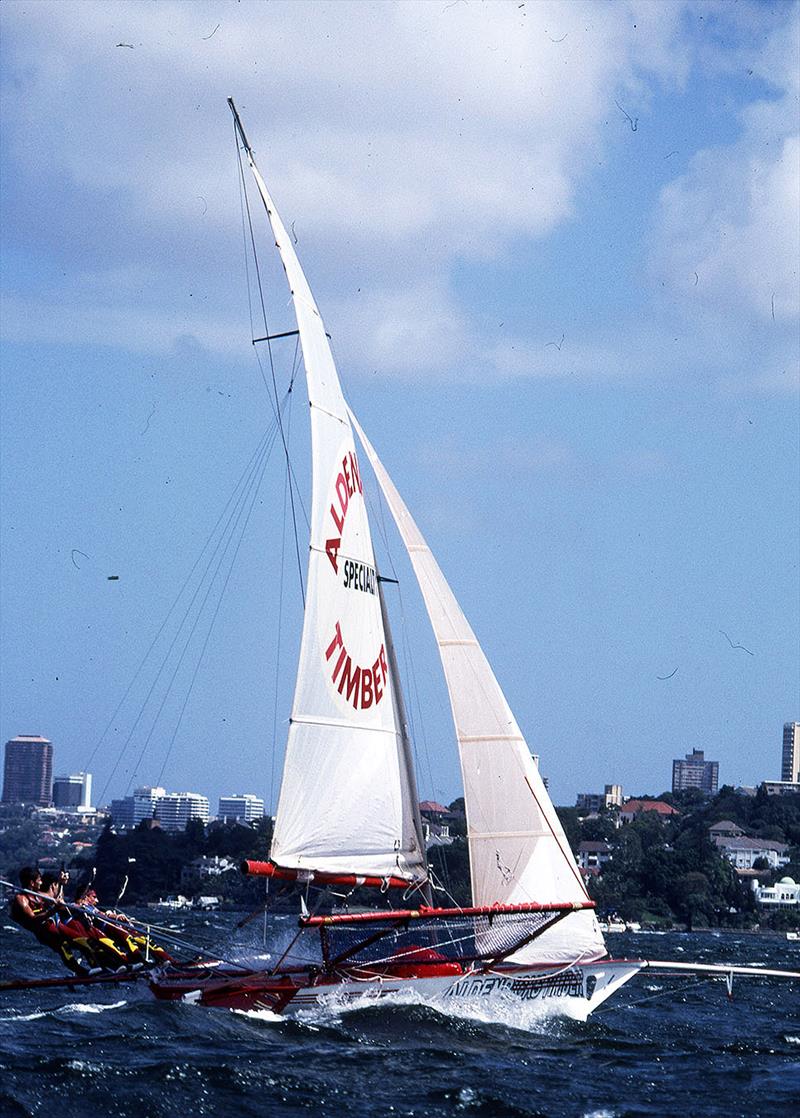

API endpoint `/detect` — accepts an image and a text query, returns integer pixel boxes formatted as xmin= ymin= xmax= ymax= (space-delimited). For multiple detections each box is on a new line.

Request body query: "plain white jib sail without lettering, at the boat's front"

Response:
xmin=350 ymin=411 xmax=606 ymax=963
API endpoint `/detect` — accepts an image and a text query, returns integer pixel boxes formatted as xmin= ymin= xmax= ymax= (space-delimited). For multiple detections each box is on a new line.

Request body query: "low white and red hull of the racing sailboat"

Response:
xmin=151 ymin=959 xmax=642 ymax=1021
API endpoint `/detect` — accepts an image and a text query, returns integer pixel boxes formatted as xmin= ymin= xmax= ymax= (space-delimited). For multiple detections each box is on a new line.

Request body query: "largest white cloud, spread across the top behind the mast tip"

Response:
xmin=4 ymin=0 xmax=683 ymax=255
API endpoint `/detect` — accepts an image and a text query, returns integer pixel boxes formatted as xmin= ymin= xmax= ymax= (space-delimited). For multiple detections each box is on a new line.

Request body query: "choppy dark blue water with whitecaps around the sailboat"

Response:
xmin=0 ymin=915 xmax=800 ymax=1118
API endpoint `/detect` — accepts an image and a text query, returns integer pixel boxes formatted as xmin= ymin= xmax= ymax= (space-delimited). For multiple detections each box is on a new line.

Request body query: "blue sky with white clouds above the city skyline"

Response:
xmin=0 ymin=0 xmax=800 ymax=803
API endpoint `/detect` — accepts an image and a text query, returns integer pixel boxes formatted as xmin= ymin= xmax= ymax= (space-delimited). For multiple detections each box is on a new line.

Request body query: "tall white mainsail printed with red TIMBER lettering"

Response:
xmin=242 ymin=152 xmax=427 ymax=881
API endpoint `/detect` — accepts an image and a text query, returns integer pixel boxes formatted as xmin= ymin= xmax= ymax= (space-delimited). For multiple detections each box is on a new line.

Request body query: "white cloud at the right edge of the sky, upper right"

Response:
xmin=653 ymin=8 xmax=800 ymax=322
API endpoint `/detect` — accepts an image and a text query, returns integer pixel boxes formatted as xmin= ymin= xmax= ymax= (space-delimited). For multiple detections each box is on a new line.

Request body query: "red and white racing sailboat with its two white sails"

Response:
xmin=151 ymin=101 xmax=795 ymax=1020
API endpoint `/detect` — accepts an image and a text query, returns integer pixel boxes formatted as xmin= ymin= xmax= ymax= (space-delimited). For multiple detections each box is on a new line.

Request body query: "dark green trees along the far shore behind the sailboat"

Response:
xmin=0 ymin=787 xmax=800 ymax=931
